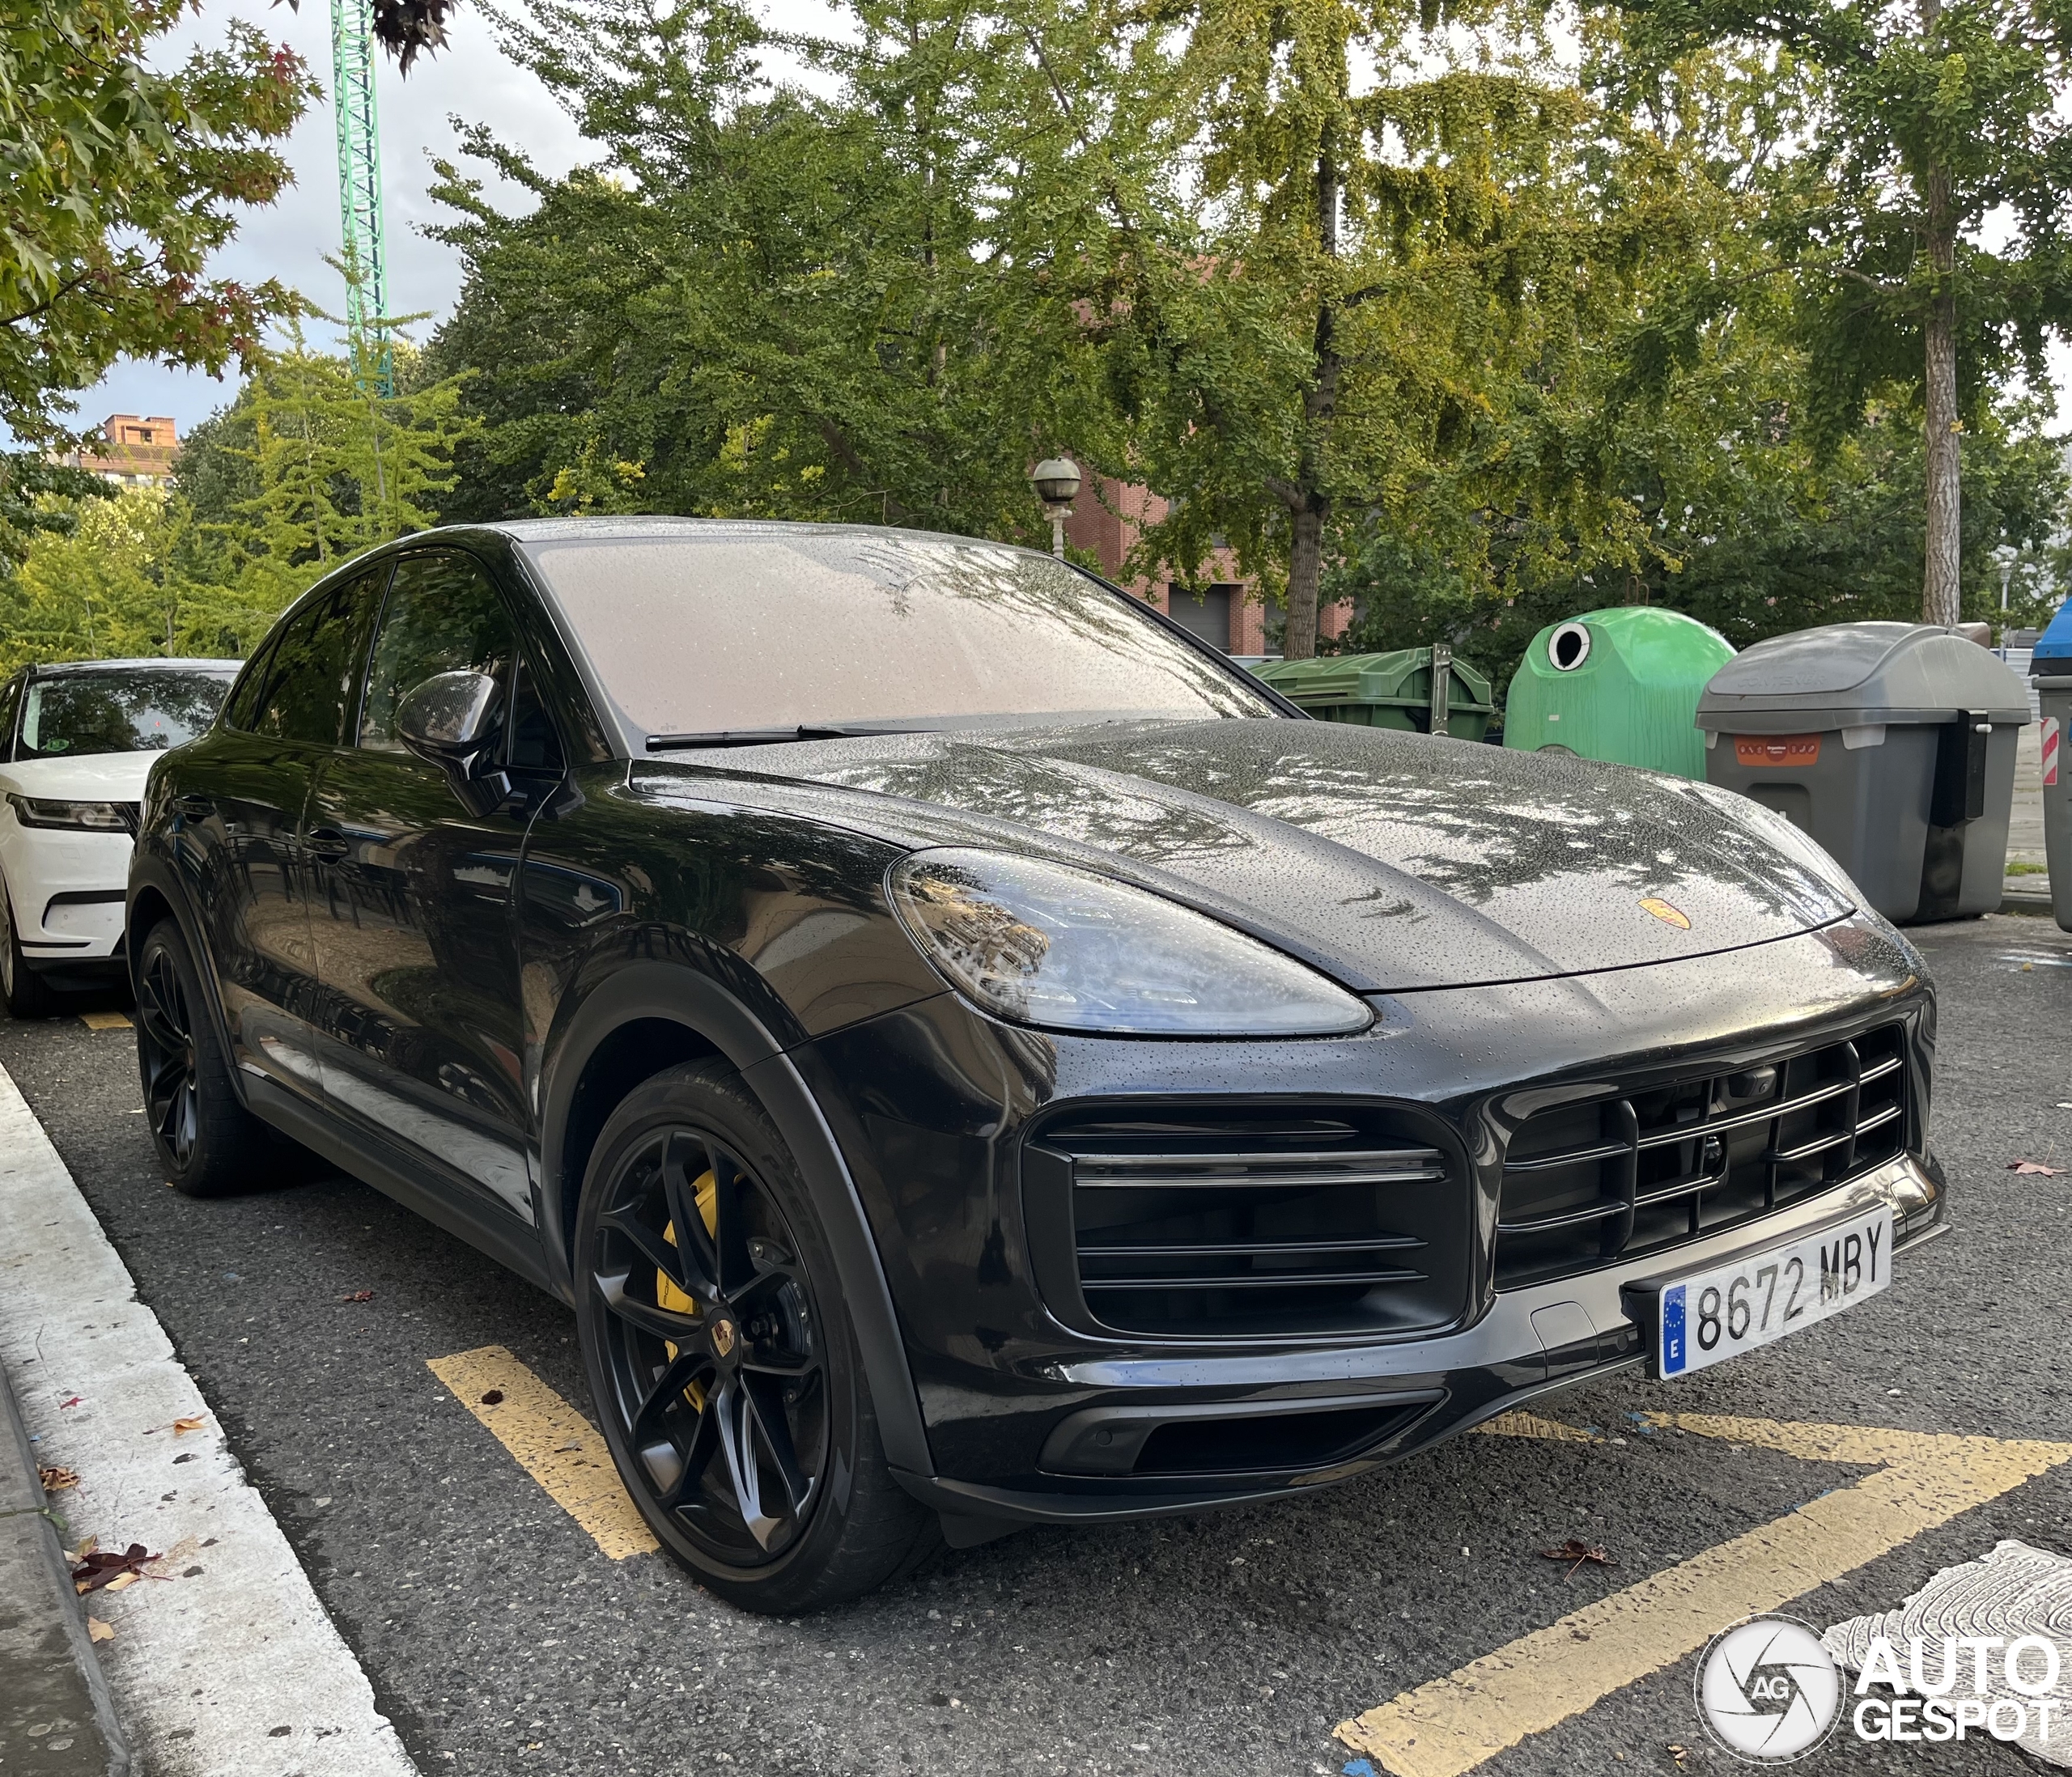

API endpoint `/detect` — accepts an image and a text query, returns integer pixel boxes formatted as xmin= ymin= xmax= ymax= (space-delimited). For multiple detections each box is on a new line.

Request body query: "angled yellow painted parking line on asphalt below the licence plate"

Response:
xmin=1339 ymin=1413 xmax=2072 ymax=1777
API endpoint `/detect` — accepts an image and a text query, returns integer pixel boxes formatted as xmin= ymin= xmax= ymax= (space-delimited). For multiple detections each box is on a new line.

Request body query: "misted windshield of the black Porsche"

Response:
xmin=529 ymin=528 xmax=1280 ymax=740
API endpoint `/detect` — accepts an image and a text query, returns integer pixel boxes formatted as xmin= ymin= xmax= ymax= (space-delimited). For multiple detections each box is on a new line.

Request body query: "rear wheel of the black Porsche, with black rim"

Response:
xmin=137 ymin=919 xmax=271 ymax=1197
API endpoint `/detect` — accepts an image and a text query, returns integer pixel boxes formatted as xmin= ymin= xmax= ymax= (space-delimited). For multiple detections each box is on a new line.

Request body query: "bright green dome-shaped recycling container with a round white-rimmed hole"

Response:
xmin=1505 ymin=604 xmax=1734 ymax=778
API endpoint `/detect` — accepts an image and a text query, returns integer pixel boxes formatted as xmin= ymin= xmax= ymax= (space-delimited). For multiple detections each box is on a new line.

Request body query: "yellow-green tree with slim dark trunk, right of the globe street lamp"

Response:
xmin=1132 ymin=0 xmax=1740 ymax=659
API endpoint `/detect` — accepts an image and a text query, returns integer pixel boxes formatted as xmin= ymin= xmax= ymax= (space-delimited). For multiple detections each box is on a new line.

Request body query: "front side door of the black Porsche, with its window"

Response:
xmin=307 ymin=551 xmax=534 ymax=1222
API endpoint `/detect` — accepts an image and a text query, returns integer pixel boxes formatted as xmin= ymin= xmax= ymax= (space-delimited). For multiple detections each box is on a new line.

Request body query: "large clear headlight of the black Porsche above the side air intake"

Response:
xmin=891 ymin=849 xmax=1374 ymax=1037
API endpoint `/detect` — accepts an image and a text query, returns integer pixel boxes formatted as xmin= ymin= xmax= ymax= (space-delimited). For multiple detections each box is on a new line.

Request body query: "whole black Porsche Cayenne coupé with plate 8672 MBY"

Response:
xmin=129 ymin=520 xmax=1943 ymax=1611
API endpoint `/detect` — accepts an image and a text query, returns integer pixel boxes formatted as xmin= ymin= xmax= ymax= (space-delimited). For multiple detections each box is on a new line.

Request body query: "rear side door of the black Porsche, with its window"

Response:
xmin=166 ymin=566 xmax=385 ymax=1098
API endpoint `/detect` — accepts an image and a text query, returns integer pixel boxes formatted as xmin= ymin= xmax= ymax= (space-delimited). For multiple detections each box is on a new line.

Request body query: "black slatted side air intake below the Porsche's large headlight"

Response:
xmin=1042 ymin=1108 xmax=1467 ymax=1336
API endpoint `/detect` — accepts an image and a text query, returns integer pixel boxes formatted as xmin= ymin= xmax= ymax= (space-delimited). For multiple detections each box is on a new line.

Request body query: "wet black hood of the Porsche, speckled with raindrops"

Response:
xmin=640 ymin=719 xmax=1853 ymax=992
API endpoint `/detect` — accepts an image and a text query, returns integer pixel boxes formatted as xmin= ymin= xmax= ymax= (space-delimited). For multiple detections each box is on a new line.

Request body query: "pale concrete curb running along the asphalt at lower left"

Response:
xmin=0 ymin=1069 xmax=417 ymax=1777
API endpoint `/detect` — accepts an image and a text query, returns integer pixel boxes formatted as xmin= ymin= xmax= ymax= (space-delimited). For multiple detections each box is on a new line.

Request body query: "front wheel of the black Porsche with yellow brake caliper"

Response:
xmin=574 ymin=1062 xmax=940 ymax=1614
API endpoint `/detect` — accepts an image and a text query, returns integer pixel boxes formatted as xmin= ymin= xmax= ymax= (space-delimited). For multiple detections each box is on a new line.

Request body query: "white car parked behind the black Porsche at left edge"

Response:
xmin=0 ymin=660 xmax=240 ymax=1019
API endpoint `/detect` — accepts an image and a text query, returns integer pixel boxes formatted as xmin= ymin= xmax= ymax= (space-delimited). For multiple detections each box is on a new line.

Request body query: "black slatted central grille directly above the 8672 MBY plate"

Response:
xmin=1496 ymin=1023 xmax=1906 ymax=1288
